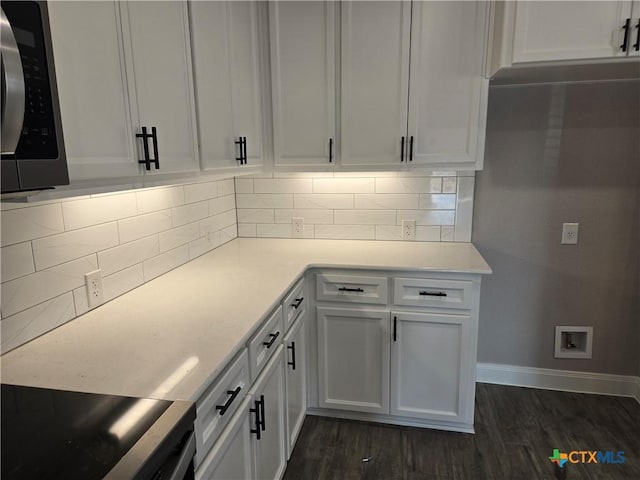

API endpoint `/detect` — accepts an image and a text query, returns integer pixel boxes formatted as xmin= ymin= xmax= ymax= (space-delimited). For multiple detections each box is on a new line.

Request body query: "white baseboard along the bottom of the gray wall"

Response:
xmin=476 ymin=363 xmax=640 ymax=402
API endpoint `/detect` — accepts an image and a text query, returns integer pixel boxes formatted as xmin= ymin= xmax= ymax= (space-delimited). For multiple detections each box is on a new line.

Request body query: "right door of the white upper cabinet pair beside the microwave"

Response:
xmin=120 ymin=1 xmax=200 ymax=173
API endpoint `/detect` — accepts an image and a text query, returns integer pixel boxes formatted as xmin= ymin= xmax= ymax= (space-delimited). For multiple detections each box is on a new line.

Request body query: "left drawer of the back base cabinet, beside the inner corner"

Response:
xmin=316 ymin=273 xmax=388 ymax=305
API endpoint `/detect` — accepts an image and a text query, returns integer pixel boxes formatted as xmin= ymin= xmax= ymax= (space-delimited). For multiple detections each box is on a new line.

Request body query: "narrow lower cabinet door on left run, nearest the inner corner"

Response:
xmin=284 ymin=311 xmax=307 ymax=459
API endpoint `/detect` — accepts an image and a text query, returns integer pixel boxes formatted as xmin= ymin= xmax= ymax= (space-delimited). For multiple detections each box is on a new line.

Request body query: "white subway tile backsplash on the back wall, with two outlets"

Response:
xmin=236 ymin=172 xmax=474 ymax=242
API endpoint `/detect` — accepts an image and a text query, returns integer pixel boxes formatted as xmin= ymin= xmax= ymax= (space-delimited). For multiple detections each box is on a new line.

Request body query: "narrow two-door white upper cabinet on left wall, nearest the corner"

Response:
xmin=189 ymin=2 xmax=263 ymax=170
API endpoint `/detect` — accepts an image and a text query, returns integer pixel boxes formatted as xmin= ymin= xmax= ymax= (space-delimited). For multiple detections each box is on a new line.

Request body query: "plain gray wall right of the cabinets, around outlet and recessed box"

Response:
xmin=472 ymin=81 xmax=640 ymax=375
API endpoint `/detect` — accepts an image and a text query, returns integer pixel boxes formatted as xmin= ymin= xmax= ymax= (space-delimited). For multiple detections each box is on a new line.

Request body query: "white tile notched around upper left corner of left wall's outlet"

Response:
xmin=2 ymin=254 xmax=98 ymax=318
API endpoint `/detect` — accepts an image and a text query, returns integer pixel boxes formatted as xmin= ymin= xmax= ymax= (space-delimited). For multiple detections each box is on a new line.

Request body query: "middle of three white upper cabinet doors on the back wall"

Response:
xmin=340 ymin=1 xmax=411 ymax=165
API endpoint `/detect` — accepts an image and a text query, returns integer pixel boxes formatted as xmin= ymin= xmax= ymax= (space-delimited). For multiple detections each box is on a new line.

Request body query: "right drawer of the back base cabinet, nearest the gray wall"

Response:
xmin=393 ymin=278 xmax=471 ymax=310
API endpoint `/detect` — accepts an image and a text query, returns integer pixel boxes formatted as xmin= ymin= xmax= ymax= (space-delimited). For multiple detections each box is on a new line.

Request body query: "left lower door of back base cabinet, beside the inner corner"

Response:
xmin=317 ymin=307 xmax=390 ymax=413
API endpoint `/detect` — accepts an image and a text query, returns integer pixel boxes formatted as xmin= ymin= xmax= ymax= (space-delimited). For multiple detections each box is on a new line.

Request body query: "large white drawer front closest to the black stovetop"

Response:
xmin=195 ymin=349 xmax=250 ymax=468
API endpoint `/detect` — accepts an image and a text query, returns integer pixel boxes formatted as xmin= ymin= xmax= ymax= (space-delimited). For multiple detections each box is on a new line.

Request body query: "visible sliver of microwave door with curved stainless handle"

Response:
xmin=0 ymin=9 xmax=25 ymax=154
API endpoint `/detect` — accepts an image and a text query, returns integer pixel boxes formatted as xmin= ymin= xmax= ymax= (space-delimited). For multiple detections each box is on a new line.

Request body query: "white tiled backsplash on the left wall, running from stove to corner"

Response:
xmin=0 ymin=179 xmax=237 ymax=353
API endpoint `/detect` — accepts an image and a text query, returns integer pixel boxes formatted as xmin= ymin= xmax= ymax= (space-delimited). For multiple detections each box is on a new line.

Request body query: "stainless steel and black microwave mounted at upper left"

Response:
xmin=0 ymin=1 xmax=69 ymax=194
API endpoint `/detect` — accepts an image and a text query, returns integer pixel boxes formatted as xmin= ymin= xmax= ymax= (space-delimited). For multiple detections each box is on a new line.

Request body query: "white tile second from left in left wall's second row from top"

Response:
xmin=33 ymin=222 xmax=118 ymax=270
